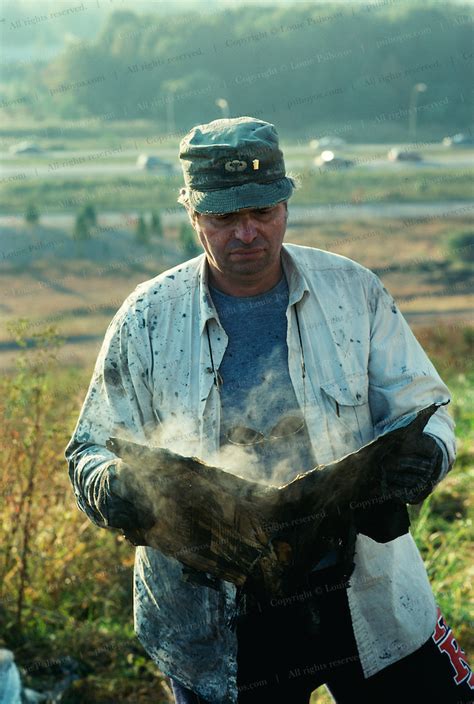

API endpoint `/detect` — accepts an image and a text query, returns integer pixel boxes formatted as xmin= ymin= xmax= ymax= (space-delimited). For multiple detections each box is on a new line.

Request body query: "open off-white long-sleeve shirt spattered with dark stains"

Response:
xmin=66 ymin=244 xmax=455 ymax=704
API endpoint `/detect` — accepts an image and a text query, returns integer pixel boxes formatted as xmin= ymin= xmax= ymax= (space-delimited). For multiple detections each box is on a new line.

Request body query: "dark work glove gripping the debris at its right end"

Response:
xmin=382 ymin=433 xmax=444 ymax=504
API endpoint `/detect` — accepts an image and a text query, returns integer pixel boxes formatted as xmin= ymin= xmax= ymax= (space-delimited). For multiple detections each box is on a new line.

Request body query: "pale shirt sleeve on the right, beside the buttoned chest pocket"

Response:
xmin=368 ymin=274 xmax=456 ymax=479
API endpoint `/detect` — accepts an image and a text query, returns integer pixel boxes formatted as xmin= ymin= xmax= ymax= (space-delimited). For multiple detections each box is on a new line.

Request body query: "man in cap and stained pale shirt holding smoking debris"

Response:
xmin=66 ymin=117 xmax=470 ymax=704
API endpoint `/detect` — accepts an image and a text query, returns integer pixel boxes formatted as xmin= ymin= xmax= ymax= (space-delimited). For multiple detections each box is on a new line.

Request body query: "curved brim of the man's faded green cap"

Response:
xmin=179 ymin=176 xmax=294 ymax=214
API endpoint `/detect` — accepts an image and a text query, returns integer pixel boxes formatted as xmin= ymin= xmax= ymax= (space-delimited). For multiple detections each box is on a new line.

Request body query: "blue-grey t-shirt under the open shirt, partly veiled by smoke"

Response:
xmin=210 ymin=275 xmax=316 ymax=484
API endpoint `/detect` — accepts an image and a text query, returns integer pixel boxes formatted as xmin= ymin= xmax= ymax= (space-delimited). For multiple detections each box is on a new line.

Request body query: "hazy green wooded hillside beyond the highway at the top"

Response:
xmin=3 ymin=0 xmax=473 ymax=139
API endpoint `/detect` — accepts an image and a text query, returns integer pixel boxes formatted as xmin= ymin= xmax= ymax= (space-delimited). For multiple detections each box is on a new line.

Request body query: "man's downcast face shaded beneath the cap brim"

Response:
xmin=194 ymin=202 xmax=287 ymax=283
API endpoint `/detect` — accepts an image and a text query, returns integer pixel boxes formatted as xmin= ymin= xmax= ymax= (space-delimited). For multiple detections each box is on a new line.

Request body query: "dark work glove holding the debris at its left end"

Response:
xmin=105 ymin=459 xmax=155 ymax=546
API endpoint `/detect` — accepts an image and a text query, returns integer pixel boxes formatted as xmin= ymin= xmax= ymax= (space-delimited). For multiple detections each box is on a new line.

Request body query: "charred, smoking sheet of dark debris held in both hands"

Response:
xmin=107 ymin=404 xmax=440 ymax=595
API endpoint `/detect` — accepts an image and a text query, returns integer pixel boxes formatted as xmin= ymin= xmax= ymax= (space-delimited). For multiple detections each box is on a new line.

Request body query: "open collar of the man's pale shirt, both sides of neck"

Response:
xmin=198 ymin=245 xmax=309 ymax=335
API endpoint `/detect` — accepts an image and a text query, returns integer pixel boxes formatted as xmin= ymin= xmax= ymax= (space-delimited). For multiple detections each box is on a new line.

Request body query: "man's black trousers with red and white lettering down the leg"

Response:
xmin=172 ymin=588 xmax=474 ymax=704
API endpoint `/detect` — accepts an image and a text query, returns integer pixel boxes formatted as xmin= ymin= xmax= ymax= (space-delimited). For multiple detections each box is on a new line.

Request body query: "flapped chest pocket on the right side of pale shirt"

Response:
xmin=320 ymin=374 xmax=373 ymax=452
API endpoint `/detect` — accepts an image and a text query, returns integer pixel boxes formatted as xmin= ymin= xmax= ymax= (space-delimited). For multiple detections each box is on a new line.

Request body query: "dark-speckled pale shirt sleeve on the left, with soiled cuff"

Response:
xmin=65 ymin=304 xmax=156 ymax=527
